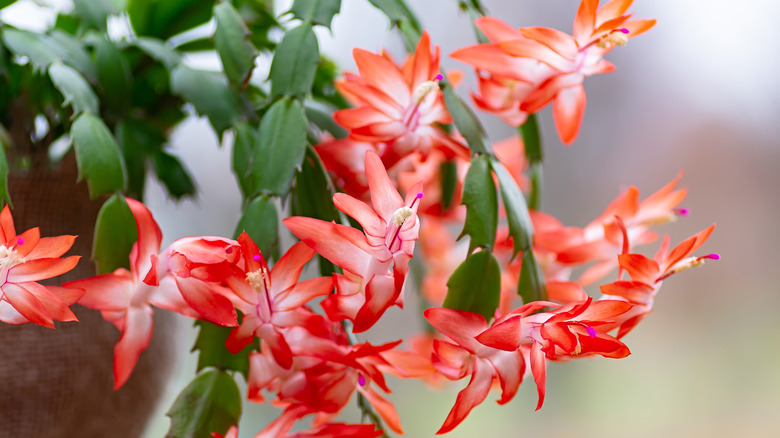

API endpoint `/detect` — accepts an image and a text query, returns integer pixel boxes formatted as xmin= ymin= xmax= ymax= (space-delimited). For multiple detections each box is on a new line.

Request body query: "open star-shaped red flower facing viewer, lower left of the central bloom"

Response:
xmin=226 ymin=233 xmax=333 ymax=368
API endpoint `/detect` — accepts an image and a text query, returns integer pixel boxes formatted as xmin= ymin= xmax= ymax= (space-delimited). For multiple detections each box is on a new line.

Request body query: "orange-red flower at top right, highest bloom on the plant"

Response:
xmin=451 ymin=0 xmax=655 ymax=144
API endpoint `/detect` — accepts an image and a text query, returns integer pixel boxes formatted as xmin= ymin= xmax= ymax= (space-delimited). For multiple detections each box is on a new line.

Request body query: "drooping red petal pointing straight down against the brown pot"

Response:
xmin=114 ymin=306 xmax=154 ymax=390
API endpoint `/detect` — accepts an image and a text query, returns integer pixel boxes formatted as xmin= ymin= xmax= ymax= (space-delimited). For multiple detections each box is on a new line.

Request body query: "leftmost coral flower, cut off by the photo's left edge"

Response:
xmin=0 ymin=205 xmax=84 ymax=328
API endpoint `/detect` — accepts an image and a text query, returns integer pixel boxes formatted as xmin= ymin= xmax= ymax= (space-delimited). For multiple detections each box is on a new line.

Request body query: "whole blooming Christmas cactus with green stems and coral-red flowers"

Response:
xmin=0 ymin=0 xmax=719 ymax=437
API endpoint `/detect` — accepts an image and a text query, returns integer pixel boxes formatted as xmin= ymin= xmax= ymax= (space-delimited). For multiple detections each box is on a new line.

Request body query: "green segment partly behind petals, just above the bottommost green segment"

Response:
xmin=192 ymin=321 xmax=260 ymax=379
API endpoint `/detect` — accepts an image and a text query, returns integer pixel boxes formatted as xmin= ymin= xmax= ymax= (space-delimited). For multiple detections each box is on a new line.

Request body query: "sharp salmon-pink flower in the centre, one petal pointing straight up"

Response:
xmin=284 ymin=151 xmax=422 ymax=333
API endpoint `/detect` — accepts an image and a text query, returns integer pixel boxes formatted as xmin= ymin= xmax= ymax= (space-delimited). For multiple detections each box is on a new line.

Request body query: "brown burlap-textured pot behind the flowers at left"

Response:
xmin=0 ymin=159 xmax=176 ymax=438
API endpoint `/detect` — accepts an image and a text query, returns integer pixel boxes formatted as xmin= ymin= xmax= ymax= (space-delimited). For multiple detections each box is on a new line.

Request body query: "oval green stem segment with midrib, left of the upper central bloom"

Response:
xmin=251 ymin=98 xmax=307 ymax=196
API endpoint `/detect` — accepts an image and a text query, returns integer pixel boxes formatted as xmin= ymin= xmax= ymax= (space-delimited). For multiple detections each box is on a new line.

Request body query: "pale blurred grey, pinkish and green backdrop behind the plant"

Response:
xmin=6 ymin=0 xmax=780 ymax=438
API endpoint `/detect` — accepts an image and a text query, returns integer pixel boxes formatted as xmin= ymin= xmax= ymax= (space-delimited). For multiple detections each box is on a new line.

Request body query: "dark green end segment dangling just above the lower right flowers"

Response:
xmin=444 ymin=250 xmax=501 ymax=321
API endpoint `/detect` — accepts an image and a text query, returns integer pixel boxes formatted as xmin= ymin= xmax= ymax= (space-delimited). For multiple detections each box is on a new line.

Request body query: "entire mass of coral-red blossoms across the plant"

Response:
xmin=0 ymin=0 xmax=718 ymax=437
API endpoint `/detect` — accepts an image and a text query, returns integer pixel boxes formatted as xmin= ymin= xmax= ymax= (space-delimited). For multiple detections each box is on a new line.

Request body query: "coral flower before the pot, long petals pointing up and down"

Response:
xmin=64 ymin=198 xmax=197 ymax=389
